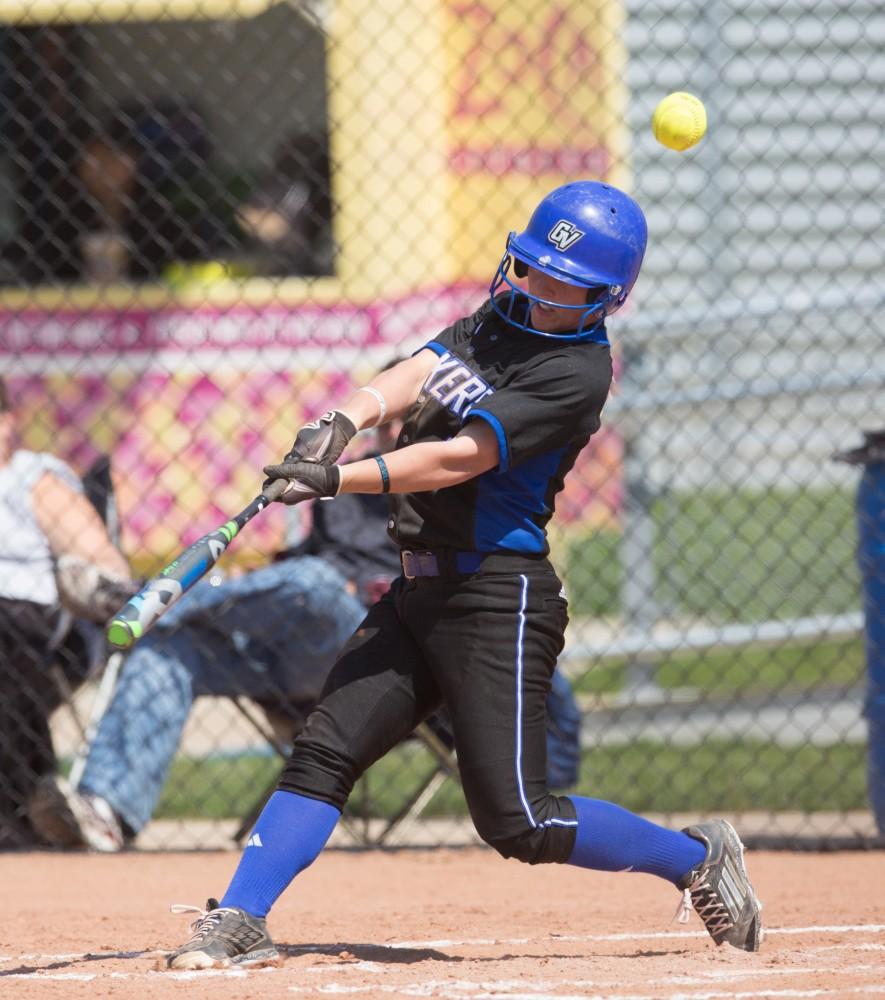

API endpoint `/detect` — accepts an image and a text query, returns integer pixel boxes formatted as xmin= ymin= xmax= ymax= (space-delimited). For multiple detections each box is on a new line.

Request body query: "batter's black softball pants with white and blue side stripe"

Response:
xmin=279 ymin=556 xmax=576 ymax=864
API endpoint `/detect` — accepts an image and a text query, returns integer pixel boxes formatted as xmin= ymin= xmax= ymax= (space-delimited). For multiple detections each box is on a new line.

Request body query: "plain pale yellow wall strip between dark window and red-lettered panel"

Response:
xmin=327 ymin=0 xmax=451 ymax=299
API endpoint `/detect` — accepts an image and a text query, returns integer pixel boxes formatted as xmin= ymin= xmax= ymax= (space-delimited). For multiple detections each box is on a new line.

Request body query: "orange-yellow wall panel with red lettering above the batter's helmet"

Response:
xmin=446 ymin=0 xmax=626 ymax=279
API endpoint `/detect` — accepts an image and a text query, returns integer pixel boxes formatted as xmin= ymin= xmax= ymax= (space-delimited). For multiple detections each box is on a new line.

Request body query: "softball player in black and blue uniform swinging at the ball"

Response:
xmin=168 ymin=181 xmax=761 ymax=969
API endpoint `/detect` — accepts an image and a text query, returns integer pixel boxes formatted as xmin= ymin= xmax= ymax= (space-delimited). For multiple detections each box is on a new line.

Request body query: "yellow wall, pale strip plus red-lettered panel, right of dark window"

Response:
xmin=328 ymin=0 xmax=627 ymax=298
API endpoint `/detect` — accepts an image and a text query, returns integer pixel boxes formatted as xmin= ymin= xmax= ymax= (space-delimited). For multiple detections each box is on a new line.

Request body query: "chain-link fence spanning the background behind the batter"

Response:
xmin=0 ymin=0 xmax=885 ymax=846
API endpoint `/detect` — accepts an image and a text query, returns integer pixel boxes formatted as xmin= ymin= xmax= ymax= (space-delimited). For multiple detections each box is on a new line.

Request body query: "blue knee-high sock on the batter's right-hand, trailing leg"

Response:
xmin=568 ymin=795 xmax=707 ymax=884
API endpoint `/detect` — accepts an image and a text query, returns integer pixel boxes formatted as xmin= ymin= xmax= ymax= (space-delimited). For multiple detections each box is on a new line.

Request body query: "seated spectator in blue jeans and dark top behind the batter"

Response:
xmin=32 ymin=425 xmax=579 ymax=851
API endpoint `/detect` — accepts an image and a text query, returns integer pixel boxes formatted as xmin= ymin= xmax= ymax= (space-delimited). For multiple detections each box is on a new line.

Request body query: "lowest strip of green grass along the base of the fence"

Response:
xmin=156 ymin=741 xmax=867 ymax=819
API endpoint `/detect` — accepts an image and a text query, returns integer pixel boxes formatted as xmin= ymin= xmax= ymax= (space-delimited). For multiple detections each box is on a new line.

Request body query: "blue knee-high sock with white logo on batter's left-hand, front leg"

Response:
xmin=221 ymin=791 xmax=341 ymax=917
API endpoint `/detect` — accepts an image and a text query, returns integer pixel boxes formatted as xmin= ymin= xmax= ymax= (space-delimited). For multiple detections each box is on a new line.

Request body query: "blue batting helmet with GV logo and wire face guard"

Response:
xmin=490 ymin=181 xmax=648 ymax=340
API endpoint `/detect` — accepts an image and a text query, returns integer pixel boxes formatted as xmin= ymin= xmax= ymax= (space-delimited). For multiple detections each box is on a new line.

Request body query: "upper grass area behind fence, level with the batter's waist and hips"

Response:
xmin=555 ymin=489 xmax=859 ymax=622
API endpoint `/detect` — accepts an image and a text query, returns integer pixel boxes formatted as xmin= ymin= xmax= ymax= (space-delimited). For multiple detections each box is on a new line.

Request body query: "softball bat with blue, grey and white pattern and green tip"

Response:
xmin=107 ymin=479 xmax=289 ymax=649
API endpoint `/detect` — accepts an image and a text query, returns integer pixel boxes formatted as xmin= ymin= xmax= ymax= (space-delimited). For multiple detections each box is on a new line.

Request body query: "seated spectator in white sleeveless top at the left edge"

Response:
xmin=0 ymin=377 xmax=134 ymax=849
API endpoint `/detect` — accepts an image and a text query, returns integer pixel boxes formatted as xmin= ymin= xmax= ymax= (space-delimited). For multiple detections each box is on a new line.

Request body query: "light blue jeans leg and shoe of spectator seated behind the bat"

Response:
xmin=30 ymin=504 xmax=374 ymax=851
